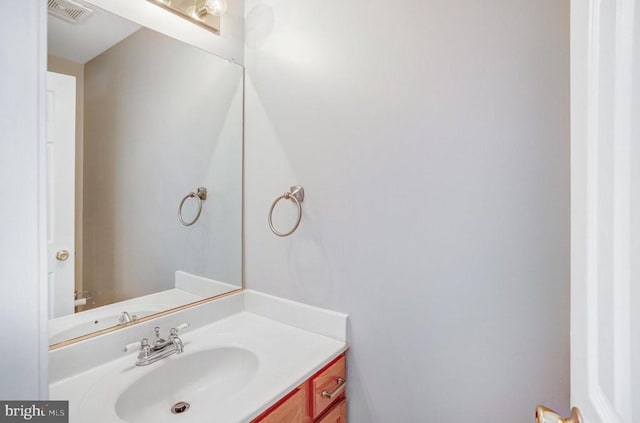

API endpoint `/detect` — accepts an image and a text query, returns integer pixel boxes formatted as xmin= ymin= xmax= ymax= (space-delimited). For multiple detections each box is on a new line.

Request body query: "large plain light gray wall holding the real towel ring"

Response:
xmin=245 ymin=0 xmax=569 ymax=423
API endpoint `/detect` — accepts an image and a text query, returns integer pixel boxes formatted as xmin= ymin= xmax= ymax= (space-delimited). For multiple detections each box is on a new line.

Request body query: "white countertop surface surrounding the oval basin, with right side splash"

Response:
xmin=50 ymin=291 xmax=347 ymax=423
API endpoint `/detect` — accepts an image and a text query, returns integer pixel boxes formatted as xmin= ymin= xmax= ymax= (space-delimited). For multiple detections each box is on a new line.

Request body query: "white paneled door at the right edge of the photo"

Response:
xmin=571 ymin=0 xmax=640 ymax=423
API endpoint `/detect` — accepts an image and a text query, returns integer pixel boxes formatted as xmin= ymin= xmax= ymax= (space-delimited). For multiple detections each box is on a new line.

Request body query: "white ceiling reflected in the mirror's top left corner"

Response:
xmin=48 ymin=0 xmax=141 ymax=64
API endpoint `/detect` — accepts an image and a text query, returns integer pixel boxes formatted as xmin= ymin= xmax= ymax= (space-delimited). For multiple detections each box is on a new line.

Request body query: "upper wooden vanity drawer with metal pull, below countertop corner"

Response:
xmin=311 ymin=355 xmax=347 ymax=419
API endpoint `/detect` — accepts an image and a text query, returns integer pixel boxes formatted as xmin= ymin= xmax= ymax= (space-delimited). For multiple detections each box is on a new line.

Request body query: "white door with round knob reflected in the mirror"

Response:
xmin=47 ymin=72 xmax=76 ymax=318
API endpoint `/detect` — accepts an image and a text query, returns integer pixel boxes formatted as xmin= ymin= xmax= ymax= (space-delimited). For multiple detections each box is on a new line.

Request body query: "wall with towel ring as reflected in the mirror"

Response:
xmin=83 ymin=29 xmax=243 ymax=305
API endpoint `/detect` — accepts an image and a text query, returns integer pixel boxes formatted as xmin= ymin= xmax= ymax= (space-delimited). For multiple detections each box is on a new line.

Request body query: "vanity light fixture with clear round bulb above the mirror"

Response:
xmin=147 ymin=0 xmax=227 ymax=34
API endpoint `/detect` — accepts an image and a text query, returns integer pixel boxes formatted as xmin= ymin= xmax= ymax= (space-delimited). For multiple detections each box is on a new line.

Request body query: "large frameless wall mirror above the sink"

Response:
xmin=47 ymin=2 xmax=243 ymax=345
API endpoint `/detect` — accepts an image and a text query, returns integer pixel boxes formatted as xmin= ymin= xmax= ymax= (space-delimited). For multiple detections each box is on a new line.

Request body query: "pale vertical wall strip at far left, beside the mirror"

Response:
xmin=0 ymin=0 xmax=49 ymax=400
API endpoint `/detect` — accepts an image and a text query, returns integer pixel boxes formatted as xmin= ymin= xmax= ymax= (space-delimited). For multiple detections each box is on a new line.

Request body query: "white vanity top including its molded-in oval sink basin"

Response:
xmin=49 ymin=300 xmax=346 ymax=423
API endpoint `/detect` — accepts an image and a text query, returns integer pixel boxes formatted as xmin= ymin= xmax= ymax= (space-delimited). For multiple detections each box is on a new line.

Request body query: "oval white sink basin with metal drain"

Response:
xmin=115 ymin=347 xmax=258 ymax=423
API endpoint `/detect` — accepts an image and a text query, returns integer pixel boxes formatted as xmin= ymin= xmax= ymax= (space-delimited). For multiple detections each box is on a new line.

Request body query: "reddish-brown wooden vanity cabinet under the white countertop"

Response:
xmin=252 ymin=354 xmax=347 ymax=423
